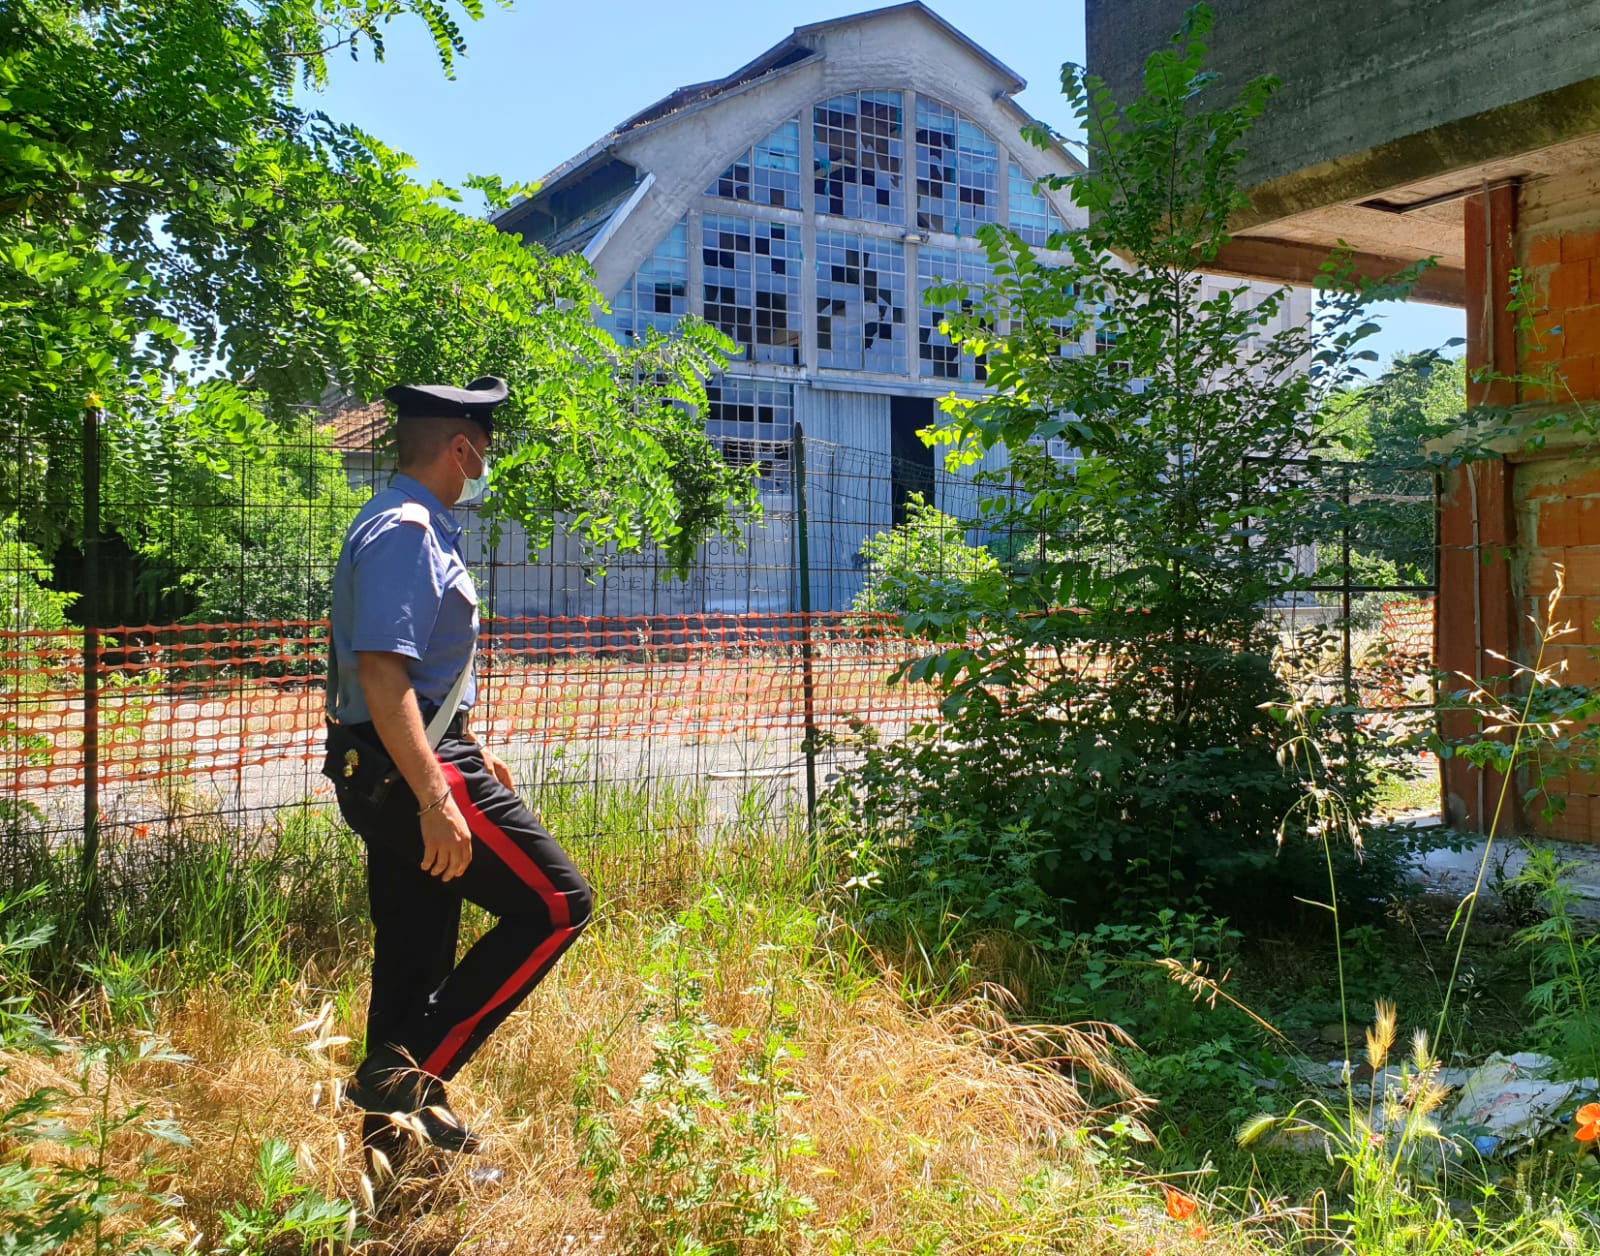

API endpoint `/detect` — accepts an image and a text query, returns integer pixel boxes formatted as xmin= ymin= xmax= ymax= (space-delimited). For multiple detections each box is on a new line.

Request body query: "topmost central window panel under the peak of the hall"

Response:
xmin=811 ymin=91 xmax=906 ymax=222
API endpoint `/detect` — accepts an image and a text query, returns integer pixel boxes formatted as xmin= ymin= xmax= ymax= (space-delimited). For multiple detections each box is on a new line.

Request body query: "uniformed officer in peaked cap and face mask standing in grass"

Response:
xmin=330 ymin=378 xmax=592 ymax=1162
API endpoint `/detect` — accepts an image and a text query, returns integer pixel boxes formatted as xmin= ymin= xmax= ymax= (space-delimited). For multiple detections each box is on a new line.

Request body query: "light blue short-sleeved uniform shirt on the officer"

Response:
xmin=324 ymin=475 xmax=478 ymax=723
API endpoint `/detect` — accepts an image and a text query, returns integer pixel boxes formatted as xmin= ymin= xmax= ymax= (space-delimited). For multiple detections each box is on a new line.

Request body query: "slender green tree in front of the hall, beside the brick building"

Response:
xmin=858 ymin=6 xmax=1420 ymax=914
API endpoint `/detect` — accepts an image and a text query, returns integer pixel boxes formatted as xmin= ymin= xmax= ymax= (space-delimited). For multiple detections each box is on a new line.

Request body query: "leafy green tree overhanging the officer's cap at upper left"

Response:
xmin=0 ymin=0 xmax=754 ymax=579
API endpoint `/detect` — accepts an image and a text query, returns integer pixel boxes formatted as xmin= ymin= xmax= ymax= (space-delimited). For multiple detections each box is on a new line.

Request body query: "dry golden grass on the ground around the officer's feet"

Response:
xmin=0 ymin=904 xmax=1280 ymax=1253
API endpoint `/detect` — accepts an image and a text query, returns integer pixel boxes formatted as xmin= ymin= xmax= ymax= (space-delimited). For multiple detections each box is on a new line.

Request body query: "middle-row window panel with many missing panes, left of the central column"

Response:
xmin=701 ymin=214 xmax=800 ymax=363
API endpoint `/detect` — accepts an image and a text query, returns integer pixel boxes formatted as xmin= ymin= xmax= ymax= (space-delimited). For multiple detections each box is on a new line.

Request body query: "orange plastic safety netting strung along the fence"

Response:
xmin=0 ymin=613 xmax=934 ymax=795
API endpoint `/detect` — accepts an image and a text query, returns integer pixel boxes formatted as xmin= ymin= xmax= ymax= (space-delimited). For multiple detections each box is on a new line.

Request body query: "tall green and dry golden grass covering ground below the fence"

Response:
xmin=0 ymin=779 xmax=1222 ymax=1256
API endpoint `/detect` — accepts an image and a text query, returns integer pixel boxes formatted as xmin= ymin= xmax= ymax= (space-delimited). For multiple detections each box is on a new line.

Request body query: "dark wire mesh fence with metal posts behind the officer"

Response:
xmin=0 ymin=411 xmax=1434 ymax=889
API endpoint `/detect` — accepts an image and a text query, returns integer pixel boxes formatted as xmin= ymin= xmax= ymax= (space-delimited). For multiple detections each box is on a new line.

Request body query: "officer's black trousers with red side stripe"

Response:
xmin=338 ymin=736 xmax=594 ymax=1082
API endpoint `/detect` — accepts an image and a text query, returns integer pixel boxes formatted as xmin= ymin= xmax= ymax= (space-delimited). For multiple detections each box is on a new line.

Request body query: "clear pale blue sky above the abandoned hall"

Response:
xmin=302 ymin=0 xmax=1464 ymax=372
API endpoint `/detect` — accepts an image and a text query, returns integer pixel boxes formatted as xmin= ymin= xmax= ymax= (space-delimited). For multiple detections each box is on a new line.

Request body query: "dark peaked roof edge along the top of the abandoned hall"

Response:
xmin=491 ymin=0 xmax=1070 ymax=240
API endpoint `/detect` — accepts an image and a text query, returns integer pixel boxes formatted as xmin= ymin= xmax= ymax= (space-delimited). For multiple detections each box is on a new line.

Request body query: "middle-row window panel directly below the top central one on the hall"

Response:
xmin=816 ymin=230 xmax=906 ymax=374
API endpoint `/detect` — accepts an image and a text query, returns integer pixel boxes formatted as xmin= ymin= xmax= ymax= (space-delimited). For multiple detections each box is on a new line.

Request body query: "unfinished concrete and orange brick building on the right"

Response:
xmin=1086 ymin=0 xmax=1600 ymax=840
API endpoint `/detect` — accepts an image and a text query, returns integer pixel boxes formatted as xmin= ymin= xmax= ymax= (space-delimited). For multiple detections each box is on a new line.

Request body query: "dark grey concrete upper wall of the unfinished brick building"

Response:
xmin=1085 ymin=0 xmax=1600 ymax=193
